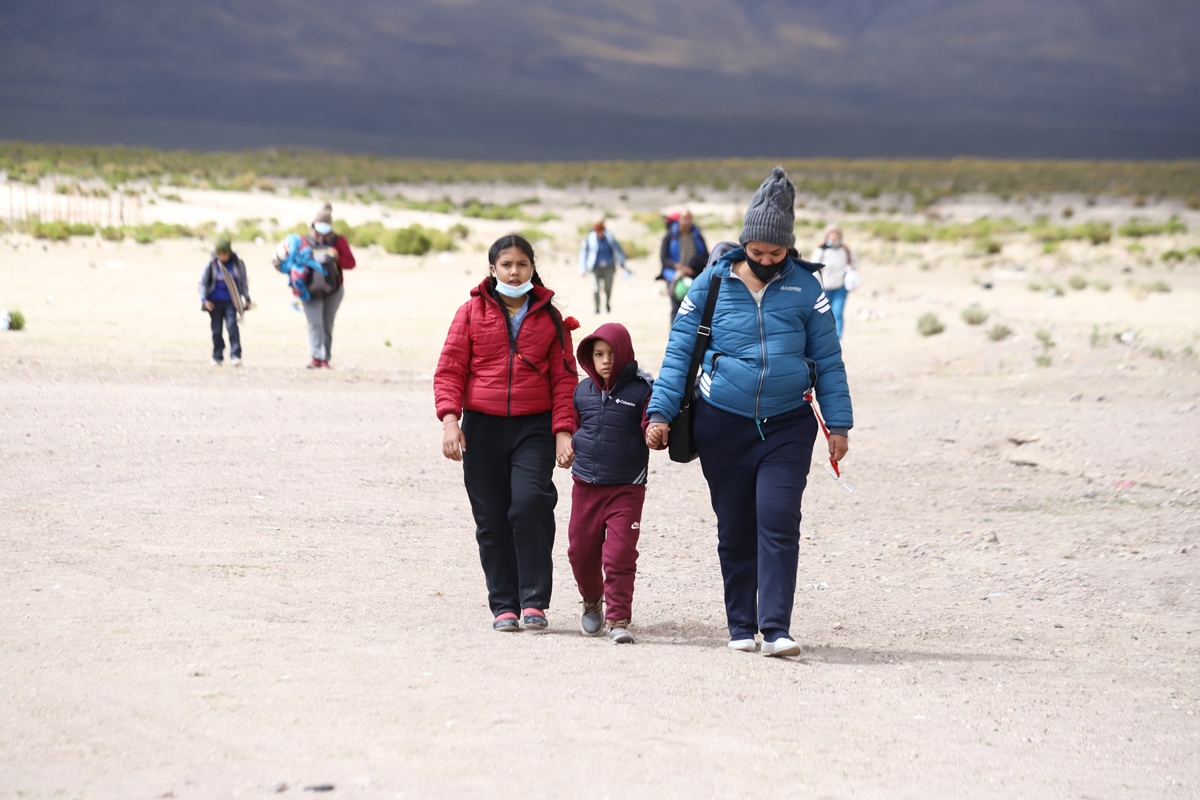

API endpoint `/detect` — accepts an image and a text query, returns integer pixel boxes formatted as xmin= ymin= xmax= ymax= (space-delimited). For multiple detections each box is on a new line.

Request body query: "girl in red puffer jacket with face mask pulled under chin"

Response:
xmin=433 ymin=234 xmax=578 ymax=631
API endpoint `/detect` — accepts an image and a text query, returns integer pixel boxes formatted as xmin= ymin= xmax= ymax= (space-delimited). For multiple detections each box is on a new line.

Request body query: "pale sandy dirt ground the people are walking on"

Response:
xmin=0 ymin=209 xmax=1200 ymax=800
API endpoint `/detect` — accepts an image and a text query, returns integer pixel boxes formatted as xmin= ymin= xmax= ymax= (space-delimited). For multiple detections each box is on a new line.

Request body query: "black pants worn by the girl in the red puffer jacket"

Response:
xmin=462 ymin=411 xmax=558 ymax=615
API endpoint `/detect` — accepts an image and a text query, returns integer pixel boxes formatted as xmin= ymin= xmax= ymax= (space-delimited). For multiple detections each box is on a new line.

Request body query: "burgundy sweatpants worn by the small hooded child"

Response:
xmin=566 ymin=481 xmax=646 ymax=620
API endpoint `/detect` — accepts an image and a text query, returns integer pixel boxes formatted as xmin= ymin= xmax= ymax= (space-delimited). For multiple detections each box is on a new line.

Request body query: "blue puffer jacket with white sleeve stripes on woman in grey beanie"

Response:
xmin=648 ymin=247 xmax=854 ymax=434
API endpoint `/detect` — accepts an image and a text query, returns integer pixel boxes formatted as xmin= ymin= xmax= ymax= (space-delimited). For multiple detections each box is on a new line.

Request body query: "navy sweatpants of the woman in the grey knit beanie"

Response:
xmin=696 ymin=398 xmax=817 ymax=642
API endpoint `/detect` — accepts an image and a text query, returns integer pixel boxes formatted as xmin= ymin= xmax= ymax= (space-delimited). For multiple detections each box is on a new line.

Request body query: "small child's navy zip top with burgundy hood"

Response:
xmin=571 ymin=323 xmax=654 ymax=486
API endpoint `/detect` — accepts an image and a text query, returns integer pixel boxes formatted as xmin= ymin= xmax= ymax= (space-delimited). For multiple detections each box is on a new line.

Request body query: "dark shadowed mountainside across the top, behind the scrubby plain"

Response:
xmin=0 ymin=0 xmax=1200 ymax=160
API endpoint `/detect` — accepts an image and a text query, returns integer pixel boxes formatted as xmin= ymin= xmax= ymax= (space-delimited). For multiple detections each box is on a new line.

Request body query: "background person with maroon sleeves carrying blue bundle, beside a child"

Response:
xmin=271 ymin=203 xmax=355 ymax=369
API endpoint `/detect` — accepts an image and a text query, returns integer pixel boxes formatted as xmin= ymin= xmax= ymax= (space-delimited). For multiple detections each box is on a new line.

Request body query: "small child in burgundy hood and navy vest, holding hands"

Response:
xmin=566 ymin=323 xmax=654 ymax=644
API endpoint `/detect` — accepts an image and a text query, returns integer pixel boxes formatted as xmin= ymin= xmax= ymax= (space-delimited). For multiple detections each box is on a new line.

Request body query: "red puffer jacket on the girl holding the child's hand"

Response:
xmin=433 ymin=279 xmax=578 ymax=433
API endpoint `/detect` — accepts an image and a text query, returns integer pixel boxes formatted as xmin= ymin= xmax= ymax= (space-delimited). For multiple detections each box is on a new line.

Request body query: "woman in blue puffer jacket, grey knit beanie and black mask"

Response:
xmin=646 ymin=167 xmax=854 ymax=656
